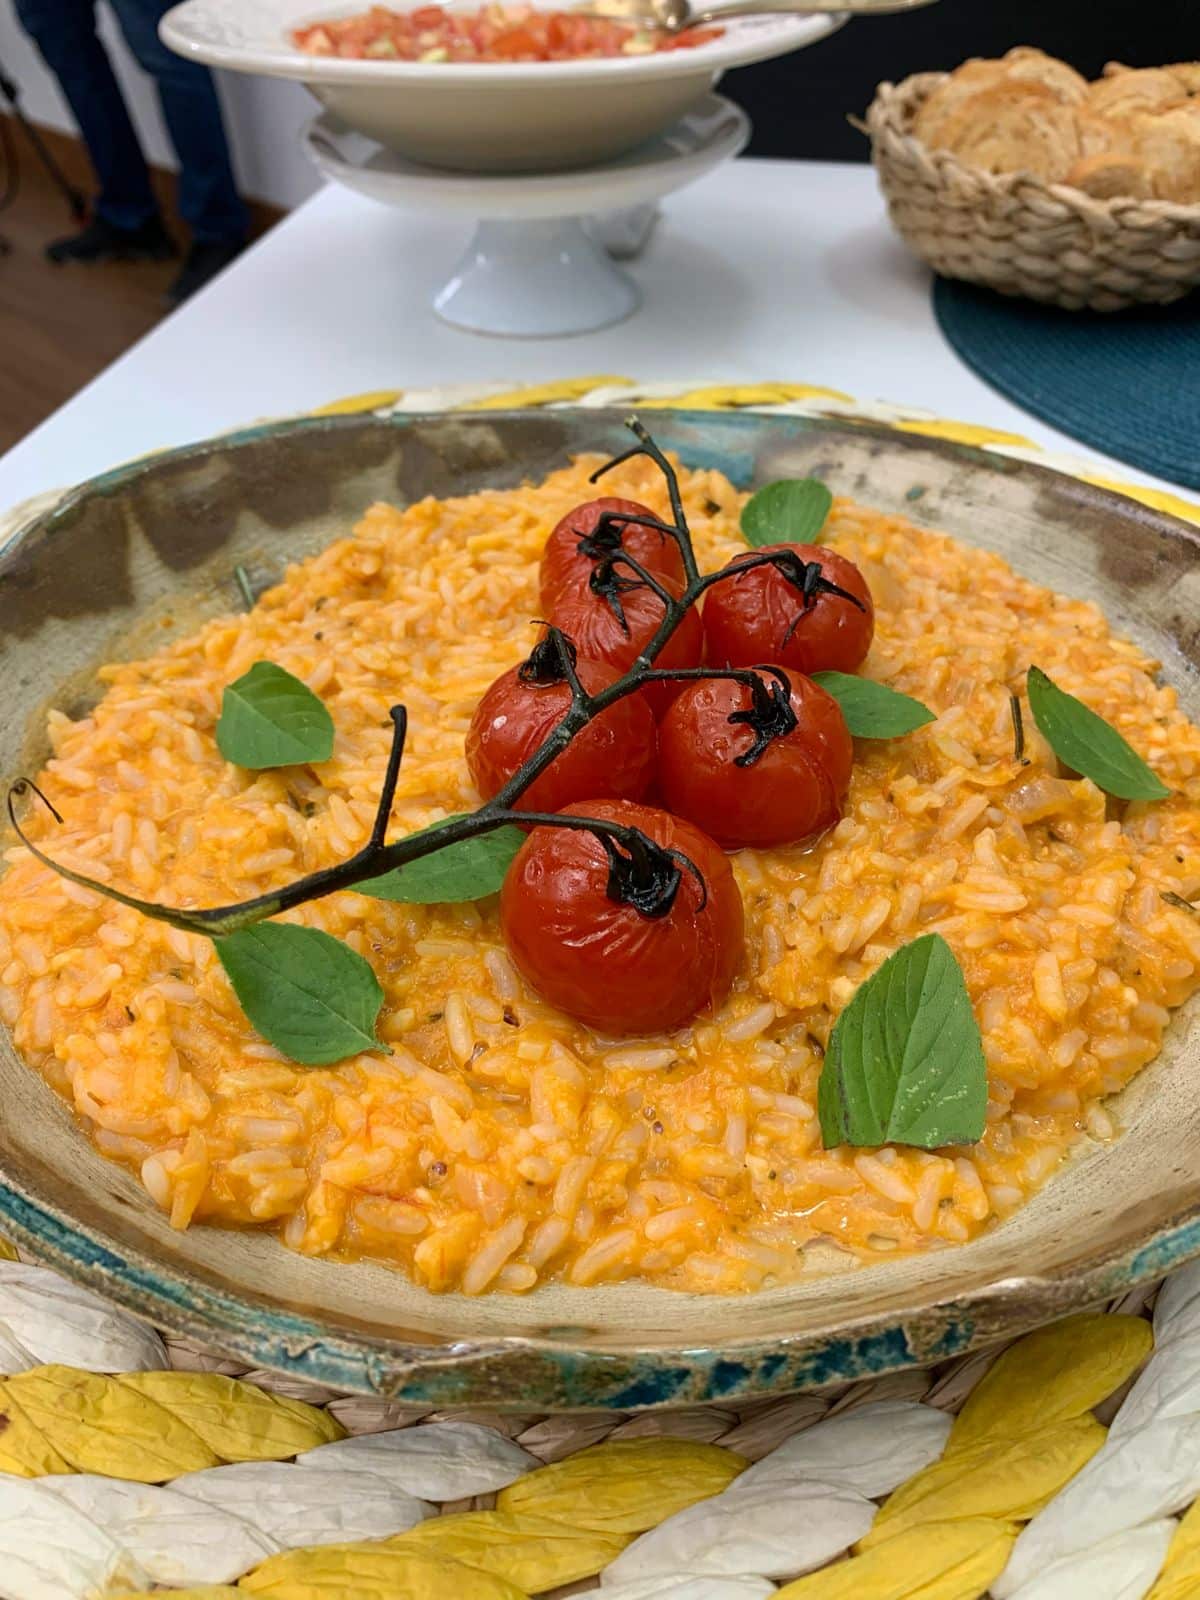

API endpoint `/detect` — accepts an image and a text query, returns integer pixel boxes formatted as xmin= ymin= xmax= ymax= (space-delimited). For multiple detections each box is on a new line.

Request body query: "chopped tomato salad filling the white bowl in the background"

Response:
xmin=293 ymin=5 xmax=723 ymax=62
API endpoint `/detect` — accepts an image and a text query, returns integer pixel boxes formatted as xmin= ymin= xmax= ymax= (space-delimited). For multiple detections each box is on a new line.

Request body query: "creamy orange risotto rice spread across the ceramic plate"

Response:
xmin=0 ymin=462 xmax=1200 ymax=1294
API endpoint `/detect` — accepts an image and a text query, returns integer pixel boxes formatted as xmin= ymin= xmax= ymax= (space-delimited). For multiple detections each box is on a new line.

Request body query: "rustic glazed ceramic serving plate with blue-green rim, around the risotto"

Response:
xmin=0 ymin=410 xmax=1200 ymax=1411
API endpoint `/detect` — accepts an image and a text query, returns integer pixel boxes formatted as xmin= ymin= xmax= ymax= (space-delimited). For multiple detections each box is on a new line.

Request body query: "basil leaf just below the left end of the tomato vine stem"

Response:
xmin=213 ymin=922 xmax=387 ymax=1067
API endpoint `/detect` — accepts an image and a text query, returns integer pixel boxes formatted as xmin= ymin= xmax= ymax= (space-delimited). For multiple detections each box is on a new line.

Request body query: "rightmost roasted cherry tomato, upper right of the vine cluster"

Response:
xmin=704 ymin=544 xmax=875 ymax=672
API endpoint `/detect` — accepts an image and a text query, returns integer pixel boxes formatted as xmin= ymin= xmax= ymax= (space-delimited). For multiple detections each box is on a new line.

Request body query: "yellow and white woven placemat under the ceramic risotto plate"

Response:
xmin=0 ymin=378 xmax=1200 ymax=1600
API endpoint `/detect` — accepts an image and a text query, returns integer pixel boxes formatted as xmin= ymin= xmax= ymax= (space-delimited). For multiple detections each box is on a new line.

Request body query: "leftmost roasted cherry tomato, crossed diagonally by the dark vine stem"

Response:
xmin=467 ymin=638 xmax=658 ymax=811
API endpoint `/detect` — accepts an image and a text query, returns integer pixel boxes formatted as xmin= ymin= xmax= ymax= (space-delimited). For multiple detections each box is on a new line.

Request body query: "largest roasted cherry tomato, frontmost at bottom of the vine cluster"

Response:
xmin=501 ymin=800 xmax=744 ymax=1034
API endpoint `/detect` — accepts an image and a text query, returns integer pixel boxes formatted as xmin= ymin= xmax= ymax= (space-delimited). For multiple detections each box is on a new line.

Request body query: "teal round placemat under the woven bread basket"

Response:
xmin=933 ymin=278 xmax=1200 ymax=490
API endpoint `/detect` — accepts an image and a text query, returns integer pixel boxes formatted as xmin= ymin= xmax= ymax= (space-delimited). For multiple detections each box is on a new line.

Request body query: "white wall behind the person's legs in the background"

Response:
xmin=0 ymin=0 xmax=320 ymax=206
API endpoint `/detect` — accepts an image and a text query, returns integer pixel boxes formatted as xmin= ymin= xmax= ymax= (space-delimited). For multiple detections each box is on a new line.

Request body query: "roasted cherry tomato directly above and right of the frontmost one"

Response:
xmin=659 ymin=667 xmax=854 ymax=850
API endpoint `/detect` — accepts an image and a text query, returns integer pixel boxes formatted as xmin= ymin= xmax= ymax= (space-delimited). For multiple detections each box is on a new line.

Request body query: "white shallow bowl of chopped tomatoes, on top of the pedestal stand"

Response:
xmin=160 ymin=0 xmax=843 ymax=173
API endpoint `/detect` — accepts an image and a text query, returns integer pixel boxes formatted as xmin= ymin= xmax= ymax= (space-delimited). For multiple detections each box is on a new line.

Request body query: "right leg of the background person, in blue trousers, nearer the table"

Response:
xmin=107 ymin=0 xmax=250 ymax=246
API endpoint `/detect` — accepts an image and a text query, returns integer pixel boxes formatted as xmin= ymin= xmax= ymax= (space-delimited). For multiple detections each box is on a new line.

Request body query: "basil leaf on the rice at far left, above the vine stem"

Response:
xmin=216 ymin=661 xmax=333 ymax=773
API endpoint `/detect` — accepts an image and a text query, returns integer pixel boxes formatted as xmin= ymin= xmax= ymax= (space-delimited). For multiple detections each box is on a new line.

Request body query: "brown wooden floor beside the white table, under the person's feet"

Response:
xmin=0 ymin=123 xmax=280 ymax=451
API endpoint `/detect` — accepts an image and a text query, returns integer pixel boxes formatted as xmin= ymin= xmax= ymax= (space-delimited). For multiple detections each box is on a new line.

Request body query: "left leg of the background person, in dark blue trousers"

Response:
xmin=16 ymin=0 xmax=169 ymax=234
